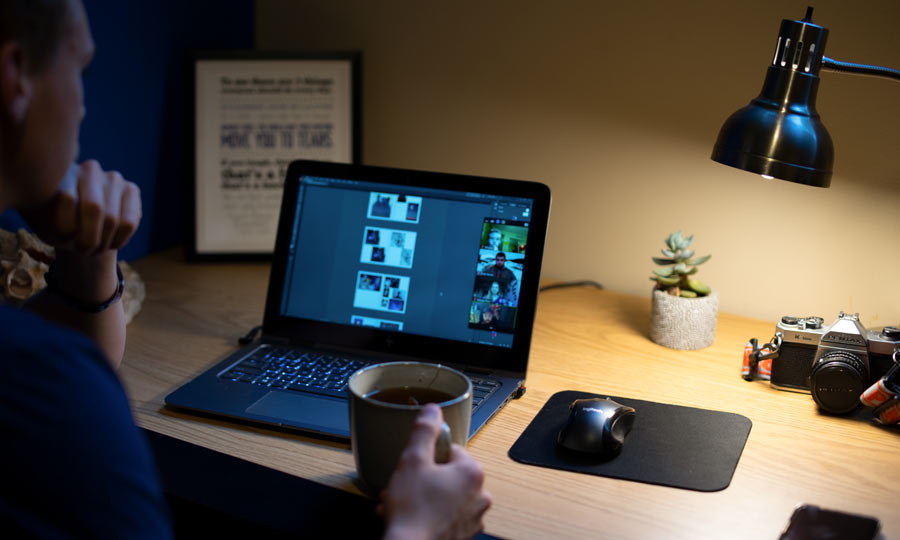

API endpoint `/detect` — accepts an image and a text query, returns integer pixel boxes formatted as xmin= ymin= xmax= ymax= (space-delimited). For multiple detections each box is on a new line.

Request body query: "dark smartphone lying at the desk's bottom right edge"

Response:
xmin=780 ymin=504 xmax=881 ymax=540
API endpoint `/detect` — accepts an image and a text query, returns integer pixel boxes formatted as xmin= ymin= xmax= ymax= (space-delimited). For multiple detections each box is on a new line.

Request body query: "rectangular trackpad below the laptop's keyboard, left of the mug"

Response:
xmin=246 ymin=392 xmax=350 ymax=434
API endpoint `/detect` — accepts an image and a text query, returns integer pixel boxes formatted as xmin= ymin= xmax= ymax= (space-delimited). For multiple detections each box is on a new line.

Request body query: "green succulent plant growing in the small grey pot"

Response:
xmin=650 ymin=231 xmax=712 ymax=298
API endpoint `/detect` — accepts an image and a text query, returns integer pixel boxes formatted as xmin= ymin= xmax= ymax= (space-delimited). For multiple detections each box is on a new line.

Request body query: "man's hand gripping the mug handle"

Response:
xmin=379 ymin=404 xmax=491 ymax=540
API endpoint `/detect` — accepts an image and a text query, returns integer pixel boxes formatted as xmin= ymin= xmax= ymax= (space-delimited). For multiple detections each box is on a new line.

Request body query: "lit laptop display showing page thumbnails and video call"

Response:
xmin=281 ymin=177 xmax=532 ymax=347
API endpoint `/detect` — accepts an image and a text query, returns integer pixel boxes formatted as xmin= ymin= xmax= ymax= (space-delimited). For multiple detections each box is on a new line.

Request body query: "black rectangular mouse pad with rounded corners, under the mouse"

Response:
xmin=509 ymin=391 xmax=751 ymax=491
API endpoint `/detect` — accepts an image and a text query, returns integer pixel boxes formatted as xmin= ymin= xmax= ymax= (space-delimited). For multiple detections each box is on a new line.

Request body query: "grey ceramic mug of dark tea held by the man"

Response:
xmin=348 ymin=362 xmax=472 ymax=493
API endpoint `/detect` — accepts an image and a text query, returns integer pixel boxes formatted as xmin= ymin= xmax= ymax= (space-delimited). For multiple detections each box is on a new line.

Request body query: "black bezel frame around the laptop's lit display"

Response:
xmin=263 ymin=160 xmax=550 ymax=375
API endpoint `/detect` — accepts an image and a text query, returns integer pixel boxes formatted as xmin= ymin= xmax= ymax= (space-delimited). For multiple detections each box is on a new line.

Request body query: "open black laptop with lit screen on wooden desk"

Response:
xmin=165 ymin=161 xmax=550 ymax=438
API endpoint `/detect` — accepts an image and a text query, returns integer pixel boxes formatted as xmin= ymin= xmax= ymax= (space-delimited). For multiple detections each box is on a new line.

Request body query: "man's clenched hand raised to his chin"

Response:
xmin=22 ymin=160 xmax=141 ymax=255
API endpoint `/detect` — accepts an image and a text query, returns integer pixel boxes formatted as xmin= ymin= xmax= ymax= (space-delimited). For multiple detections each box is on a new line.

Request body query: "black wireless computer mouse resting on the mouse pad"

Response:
xmin=556 ymin=398 xmax=635 ymax=458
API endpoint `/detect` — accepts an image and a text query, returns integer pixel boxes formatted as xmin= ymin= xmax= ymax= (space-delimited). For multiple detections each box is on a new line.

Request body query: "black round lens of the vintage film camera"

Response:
xmin=810 ymin=351 xmax=868 ymax=414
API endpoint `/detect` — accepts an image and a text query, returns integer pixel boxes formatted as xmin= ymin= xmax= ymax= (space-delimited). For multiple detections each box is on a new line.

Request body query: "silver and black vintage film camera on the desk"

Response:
xmin=771 ymin=311 xmax=900 ymax=414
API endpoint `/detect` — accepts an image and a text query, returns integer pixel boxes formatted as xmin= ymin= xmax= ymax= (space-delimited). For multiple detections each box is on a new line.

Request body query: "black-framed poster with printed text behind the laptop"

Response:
xmin=187 ymin=51 xmax=361 ymax=261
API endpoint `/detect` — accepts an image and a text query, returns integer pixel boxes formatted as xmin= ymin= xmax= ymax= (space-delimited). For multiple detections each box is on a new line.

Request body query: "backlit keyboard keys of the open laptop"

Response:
xmin=219 ymin=346 xmax=500 ymax=412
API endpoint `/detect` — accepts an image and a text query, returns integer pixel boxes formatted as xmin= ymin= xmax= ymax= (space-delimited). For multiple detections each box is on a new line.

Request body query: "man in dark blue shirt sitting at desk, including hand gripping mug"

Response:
xmin=0 ymin=0 xmax=491 ymax=540
